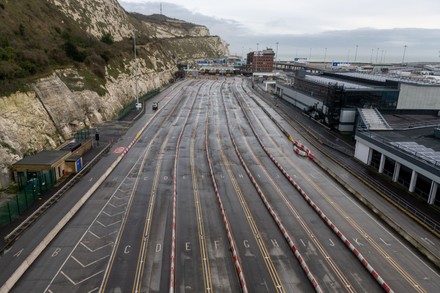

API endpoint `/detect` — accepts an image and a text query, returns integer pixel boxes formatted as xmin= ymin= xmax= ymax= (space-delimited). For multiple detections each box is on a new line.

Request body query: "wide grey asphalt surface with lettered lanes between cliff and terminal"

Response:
xmin=0 ymin=77 xmax=440 ymax=292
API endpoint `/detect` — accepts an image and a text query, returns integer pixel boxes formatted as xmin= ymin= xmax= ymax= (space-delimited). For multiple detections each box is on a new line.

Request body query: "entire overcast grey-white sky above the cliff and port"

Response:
xmin=119 ymin=0 xmax=440 ymax=63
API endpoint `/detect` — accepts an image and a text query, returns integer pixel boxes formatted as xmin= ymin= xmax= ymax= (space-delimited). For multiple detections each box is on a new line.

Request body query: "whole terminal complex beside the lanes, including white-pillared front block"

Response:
xmin=275 ymin=70 xmax=440 ymax=206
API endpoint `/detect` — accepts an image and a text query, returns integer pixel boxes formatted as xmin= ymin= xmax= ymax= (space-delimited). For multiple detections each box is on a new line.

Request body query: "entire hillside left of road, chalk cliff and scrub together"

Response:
xmin=0 ymin=0 xmax=228 ymax=189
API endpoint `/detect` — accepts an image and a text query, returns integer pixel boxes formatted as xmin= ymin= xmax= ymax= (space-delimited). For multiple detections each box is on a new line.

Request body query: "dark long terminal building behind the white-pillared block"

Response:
xmin=275 ymin=71 xmax=440 ymax=132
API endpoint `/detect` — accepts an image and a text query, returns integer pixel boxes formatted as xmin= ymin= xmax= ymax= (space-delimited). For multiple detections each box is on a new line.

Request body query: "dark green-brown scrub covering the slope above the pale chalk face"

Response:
xmin=0 ymin=0 xmax=132 ymax=96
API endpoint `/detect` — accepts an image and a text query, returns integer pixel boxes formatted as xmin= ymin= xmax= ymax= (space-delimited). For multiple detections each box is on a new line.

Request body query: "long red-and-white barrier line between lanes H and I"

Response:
xmin=222 ymin=93 xmax=323 ymax=293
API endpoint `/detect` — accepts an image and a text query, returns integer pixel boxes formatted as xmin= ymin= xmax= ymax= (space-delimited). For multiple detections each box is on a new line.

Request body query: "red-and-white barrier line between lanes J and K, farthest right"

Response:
xmin=237 ymin=82 xmax=394 ymax=293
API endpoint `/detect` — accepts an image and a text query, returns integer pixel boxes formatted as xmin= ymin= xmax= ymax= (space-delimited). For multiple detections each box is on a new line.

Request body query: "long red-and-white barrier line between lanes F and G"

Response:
xmin=205 ymin=92 xmax=248 ymax=293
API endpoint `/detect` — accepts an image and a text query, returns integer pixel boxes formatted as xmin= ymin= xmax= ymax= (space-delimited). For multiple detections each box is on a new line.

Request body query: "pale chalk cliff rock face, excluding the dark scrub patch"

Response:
xmin=0 ymin=0 xmax=228 ymax=189
